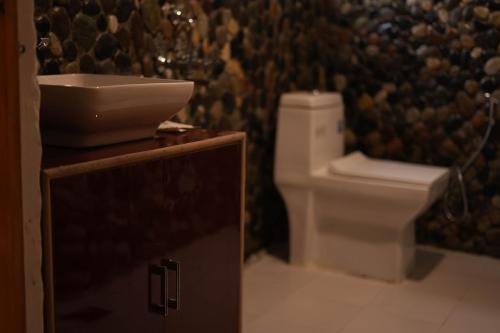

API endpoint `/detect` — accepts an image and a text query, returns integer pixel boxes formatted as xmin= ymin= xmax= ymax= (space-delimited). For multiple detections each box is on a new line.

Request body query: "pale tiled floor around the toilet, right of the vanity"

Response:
xmin=243 ymin=247 xmax=500 ymax=333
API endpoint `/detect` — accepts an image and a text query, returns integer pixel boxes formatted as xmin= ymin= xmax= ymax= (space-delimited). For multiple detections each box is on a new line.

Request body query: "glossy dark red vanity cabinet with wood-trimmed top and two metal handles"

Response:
xmin=42 ymin=130 xmax=245 ymax=333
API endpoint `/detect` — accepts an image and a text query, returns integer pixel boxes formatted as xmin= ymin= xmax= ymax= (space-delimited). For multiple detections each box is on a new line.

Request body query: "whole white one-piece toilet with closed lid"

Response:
xmin=274 ymin=92 xmax=448 ymax=282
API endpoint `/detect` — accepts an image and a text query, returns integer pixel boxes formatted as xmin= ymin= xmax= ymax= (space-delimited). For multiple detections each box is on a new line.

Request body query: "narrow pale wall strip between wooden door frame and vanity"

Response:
xmin=17 ymin=0 xmax=43 ymax=333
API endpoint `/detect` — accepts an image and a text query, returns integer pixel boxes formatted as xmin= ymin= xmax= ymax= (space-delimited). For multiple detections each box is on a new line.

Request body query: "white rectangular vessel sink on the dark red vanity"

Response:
xmin=38 ymin=74 xmax=194 ymax=147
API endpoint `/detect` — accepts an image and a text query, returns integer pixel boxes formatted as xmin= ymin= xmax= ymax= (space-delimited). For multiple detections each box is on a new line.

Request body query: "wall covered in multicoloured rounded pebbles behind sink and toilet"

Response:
xmin=35 ymin=0 xmax=500 ymax=256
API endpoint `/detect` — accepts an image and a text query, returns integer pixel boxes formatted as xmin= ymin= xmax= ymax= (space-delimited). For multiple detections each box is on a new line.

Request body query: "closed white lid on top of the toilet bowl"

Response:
xmin=330 ymin=151 xmax=448 ymax=185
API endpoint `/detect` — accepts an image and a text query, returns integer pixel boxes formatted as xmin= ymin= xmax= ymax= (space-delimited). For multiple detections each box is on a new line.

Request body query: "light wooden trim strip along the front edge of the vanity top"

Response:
xmin=42 ymin=132 xmax=246 ymax=179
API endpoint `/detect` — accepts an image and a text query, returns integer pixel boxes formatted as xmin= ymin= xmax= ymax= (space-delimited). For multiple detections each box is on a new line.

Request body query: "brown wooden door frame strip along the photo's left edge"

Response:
xmin=0 ymin=0 xmax=26 ymax=333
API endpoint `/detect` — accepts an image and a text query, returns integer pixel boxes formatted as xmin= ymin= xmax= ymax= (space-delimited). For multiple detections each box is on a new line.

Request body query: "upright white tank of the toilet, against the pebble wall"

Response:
xmin=274 ymin=92 xmax=344 ymax=183
